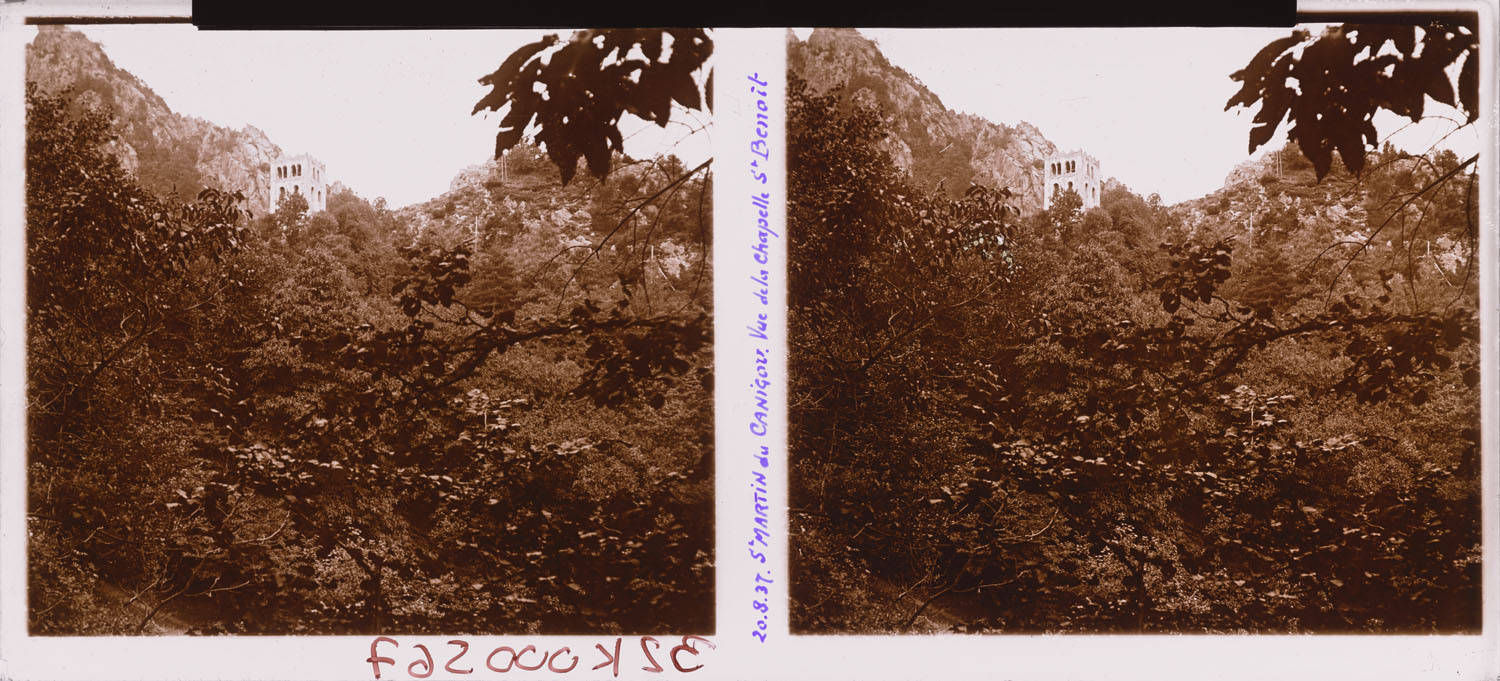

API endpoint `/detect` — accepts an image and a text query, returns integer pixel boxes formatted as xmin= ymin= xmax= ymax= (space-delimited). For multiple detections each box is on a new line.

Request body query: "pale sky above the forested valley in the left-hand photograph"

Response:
xmin=51 ymin=24 xmax=710 ymax=207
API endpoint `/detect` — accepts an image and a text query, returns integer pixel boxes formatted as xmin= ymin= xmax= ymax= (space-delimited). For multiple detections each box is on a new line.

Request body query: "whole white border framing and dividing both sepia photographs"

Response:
xmin=0 ymin=0 xmax=1500 ymax=681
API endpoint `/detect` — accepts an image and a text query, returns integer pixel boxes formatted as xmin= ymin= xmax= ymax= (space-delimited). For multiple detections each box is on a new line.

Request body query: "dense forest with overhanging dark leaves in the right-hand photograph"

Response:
xmin=788 ymin=17 xmax=1481 ymax=633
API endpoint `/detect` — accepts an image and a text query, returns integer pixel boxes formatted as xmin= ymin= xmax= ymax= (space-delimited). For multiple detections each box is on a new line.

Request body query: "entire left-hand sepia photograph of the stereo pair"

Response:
xmin=21 ymin=23 xmax=714 ymax=636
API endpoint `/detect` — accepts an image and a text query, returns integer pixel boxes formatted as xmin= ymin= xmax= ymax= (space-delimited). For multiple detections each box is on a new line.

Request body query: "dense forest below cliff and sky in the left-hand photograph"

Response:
xmin=27 ymin=36 xmax=714 ymax=635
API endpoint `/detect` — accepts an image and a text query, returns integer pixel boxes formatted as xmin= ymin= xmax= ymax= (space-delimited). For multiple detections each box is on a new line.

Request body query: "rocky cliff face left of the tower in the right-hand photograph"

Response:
xmin=788 ymin=29 xmax=1058 ymax=213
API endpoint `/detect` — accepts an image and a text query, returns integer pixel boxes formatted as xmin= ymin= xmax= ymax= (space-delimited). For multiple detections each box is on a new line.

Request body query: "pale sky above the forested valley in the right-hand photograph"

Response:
xmin=846 ymin=29 xmax=1479 ymax=203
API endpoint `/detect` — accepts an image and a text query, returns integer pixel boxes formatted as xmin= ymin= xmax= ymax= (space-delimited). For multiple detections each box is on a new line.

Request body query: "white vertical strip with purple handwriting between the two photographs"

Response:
xmin=714 ymin=23 xmax=789 ymax=678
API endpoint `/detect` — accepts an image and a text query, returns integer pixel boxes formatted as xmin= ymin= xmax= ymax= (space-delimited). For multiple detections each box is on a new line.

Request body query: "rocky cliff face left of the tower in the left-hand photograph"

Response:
xmin=26 ymin=26 xmax=282 ymax=213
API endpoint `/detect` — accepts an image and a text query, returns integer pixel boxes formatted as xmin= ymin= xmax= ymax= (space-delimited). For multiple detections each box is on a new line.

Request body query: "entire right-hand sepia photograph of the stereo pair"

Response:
xmin=786 ymin=22 xmax=1494 ymax=635
